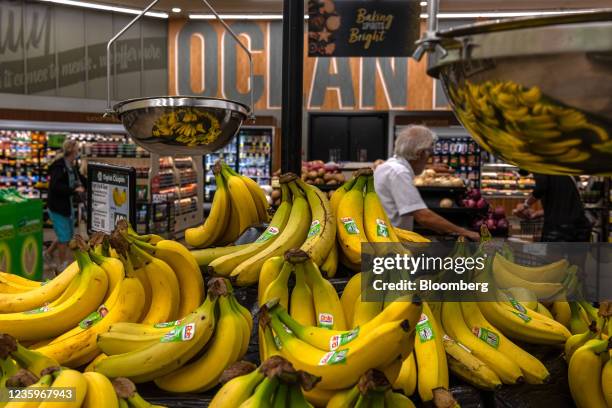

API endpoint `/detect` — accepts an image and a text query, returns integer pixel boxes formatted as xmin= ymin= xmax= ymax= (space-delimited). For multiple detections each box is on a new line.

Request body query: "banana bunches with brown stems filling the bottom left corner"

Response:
xmin=0 ymin=334 xmax=162 ymax=408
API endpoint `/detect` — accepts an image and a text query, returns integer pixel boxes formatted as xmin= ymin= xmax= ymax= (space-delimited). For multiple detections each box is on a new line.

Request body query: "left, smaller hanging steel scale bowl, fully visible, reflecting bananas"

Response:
xmin=113 ymin=96 xmax=249 ymax=156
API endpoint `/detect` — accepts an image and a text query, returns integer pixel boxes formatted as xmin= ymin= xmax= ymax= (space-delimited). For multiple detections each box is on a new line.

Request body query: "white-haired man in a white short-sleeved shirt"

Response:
xmin=374 ymin=126 xmax=479 ymax=240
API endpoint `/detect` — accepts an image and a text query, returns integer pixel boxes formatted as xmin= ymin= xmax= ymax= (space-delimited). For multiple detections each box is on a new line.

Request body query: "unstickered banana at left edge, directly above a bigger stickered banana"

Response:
xmin=0 ymin=262 xmax=80 ymax=313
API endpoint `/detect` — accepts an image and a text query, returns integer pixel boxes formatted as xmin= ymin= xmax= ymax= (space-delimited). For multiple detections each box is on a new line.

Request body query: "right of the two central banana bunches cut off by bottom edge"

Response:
xmin=327 ymin=370 xmax=424 ymax=408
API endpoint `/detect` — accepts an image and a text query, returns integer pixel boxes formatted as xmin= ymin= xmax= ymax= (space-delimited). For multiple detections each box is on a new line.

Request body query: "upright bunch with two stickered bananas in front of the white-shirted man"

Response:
xmin=331 ymin=168 xmax=429 ymax=271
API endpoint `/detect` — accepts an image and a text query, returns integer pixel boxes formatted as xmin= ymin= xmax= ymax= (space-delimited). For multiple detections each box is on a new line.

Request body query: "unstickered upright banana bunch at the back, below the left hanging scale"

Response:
xmin=185 ymin=161 xmax=269 ymax=248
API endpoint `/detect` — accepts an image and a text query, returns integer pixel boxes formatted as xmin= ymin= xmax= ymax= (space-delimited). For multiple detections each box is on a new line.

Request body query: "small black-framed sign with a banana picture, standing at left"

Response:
xmin=87 ymin=163 xmax=136 ymax=234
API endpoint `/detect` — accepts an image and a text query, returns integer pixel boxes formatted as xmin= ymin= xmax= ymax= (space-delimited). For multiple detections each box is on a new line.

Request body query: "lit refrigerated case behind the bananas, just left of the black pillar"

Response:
xmin=204 ymin=126 xmax=275 ymax=202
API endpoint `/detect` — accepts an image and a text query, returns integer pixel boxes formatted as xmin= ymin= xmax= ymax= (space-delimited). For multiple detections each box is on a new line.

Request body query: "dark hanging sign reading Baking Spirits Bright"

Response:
xmin=308 ymin=0 xmax=421 ymax=57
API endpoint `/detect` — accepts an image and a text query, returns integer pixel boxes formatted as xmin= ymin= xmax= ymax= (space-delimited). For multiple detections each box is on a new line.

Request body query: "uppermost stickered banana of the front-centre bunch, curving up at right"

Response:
xmin=269 ymin=302 xmax=422 ymax=351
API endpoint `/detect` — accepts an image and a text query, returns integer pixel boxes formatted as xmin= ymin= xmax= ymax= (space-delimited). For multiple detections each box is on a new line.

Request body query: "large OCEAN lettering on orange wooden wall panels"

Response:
xmin=168 ymin=20 xmax=433 ymax=111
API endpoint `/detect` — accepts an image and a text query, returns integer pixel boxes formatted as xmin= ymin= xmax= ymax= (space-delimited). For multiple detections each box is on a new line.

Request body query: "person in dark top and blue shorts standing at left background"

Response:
xmin=45 ymin=140 xmax=85 ymax=272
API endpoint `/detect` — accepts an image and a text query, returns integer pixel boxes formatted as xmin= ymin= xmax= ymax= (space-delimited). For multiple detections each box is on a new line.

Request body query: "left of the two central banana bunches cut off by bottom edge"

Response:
xmin=209 ymin=355 xmax=319 ymax=408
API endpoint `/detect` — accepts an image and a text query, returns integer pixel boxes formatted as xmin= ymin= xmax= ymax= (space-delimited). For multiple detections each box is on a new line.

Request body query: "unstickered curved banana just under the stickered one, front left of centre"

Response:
xmin=155 ymin=296 xmax=242 ymax=392
